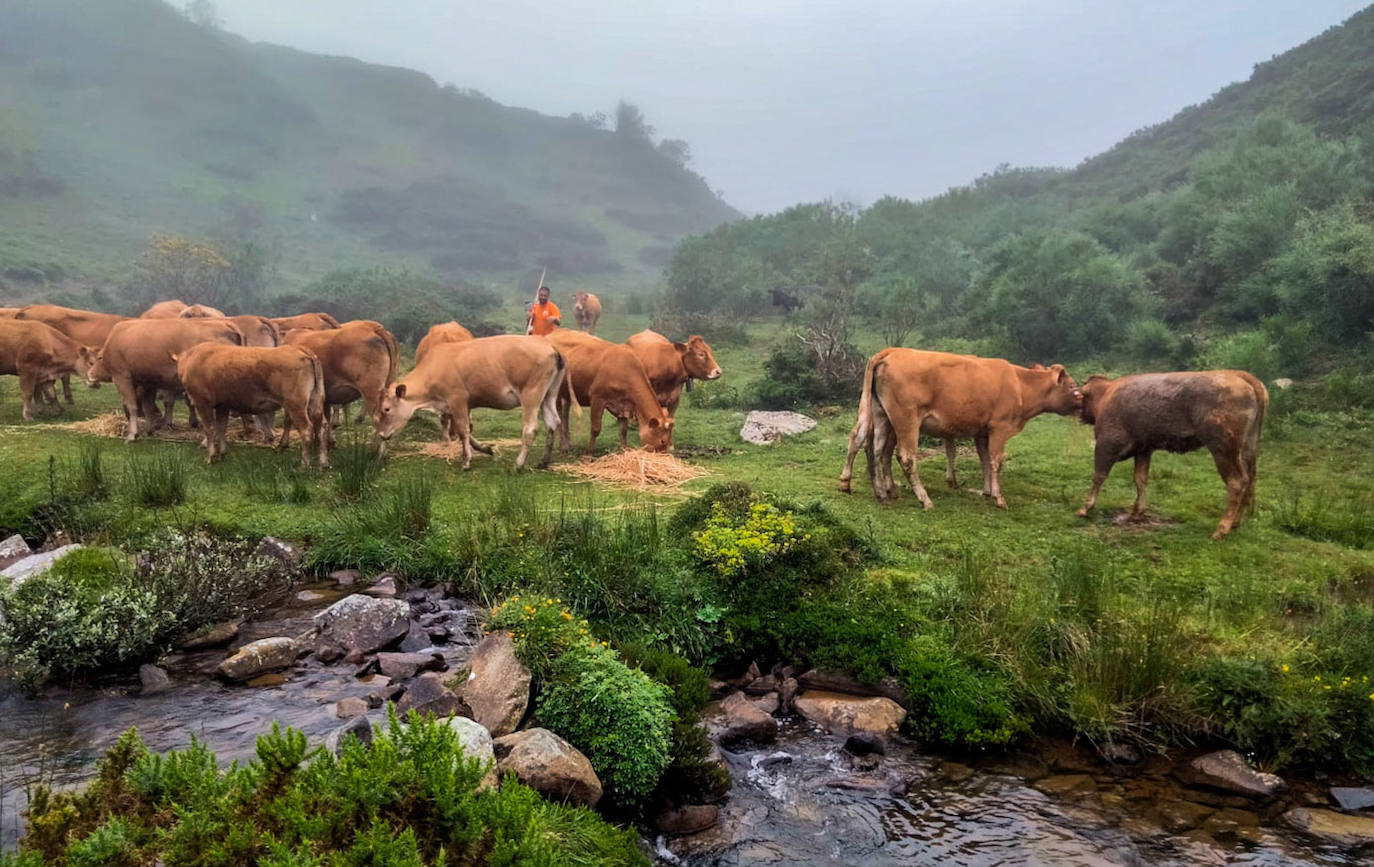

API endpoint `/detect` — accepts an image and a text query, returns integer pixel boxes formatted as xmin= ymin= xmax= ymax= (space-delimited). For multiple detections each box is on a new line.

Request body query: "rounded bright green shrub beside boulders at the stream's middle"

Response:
xmin=536 ymin=644 xmax=675 ymax=807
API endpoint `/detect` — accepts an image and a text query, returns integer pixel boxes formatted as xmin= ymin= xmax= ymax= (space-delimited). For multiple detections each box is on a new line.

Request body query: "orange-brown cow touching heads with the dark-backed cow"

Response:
xmin=840 ymin=348 xmax=1079 ymax=508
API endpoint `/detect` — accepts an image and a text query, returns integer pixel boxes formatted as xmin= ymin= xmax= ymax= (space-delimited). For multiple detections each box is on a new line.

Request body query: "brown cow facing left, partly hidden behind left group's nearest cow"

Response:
xmin=87 ymin=319 xmax=243 ymax=441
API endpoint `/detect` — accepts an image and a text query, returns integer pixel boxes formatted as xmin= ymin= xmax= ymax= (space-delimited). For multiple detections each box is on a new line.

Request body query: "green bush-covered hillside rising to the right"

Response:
xmin=669 ymin=7 xmax=1374 ymax=375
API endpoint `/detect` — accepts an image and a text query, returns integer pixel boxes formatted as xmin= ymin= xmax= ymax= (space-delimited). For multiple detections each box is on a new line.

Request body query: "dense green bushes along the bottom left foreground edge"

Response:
xmin=18 ymin=714 xmax=649 ymax=867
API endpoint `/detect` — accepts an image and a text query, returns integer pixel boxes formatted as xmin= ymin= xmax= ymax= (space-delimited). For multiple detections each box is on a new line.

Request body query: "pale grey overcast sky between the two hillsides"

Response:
xmin=216 ymin=0 xmax=1364 ymax=213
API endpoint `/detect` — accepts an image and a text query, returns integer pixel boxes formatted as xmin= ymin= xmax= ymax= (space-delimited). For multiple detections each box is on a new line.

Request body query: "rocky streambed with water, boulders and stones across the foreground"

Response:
xmin=0 ymin=572 xmax=1374 ymax=867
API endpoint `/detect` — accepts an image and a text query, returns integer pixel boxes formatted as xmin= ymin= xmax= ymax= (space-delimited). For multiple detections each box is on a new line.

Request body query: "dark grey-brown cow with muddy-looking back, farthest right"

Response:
xmin=1077 ymin=370 xmax=1270 ymax=539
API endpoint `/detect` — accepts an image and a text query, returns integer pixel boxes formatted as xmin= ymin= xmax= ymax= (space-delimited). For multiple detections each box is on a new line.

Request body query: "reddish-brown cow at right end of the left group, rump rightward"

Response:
xmin=286 ymin=319 xmax=400 ymax=445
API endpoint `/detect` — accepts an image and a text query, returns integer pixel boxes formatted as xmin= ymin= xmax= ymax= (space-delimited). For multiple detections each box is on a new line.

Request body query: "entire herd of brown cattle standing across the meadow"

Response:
xmin=0 ymin=302 xmax=1268 ymax=539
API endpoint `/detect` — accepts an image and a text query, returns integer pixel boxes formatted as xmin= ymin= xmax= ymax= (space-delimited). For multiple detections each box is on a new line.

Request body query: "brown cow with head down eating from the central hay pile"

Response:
xmin=547 ymin=328 xmax=673 ymax=455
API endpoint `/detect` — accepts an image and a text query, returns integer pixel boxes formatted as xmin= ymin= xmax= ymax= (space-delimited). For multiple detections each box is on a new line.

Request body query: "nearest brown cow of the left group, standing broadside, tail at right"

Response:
xmin=177 ymin=344 xmax=330 ymax=467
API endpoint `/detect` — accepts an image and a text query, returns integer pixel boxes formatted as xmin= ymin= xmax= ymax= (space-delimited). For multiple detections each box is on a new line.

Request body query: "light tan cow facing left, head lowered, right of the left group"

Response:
xmin=376 ymin=334 xmax=567 ymax=470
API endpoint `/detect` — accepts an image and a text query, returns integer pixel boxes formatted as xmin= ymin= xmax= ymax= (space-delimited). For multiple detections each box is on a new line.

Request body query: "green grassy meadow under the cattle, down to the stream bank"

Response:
xmin=0 ymin=315 xmax=1374 ymax=769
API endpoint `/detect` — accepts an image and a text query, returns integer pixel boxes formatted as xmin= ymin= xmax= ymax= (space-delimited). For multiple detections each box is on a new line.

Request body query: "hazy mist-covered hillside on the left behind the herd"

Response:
xmin=0 ymin=0 xmax=738 ymax=302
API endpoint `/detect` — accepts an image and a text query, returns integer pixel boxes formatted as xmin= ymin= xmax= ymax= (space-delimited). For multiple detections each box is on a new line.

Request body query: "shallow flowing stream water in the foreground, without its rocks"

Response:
xmin=0 ymin=585 xmax=1366 ymax=867
